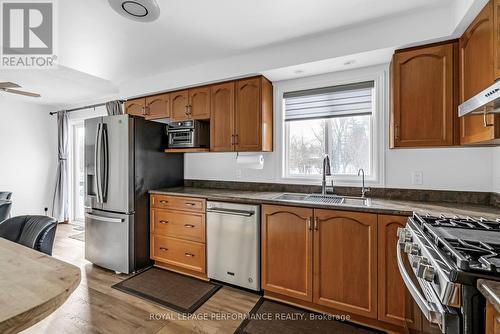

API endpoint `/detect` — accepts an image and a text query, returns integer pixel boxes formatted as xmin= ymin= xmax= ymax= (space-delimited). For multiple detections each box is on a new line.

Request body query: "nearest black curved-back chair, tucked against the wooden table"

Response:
xmin=0 ymin=216 xmax=57 ymax=255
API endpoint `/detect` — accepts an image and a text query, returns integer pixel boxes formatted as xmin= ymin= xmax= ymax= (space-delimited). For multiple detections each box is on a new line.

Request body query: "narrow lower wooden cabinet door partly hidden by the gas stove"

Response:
xmin=377 ymin=215 xmax=421 ymax=330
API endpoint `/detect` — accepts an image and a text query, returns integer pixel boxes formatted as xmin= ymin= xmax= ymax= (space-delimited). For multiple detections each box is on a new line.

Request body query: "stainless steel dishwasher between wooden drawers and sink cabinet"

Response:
xmin=207 ymin=202 xmax=260 ymax=291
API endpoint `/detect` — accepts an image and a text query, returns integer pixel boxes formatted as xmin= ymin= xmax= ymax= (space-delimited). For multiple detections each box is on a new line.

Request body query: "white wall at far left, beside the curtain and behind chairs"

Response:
xmin=0 ymin=97 xmax=57 ymax=216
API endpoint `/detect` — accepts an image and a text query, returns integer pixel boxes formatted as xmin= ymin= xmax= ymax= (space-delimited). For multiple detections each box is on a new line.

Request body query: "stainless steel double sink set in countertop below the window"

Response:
xmin=273 ymin=193 xmax=371 ymax=206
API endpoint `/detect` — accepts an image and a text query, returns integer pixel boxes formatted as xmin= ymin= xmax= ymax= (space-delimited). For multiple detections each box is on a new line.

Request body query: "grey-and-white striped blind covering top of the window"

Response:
xmin=283 ymin=81 xmax=375 ymax=121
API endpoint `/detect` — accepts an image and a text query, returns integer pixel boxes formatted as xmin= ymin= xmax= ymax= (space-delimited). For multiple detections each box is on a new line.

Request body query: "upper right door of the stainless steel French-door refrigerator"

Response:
xmin=101 ymin=115 xmax=134 ymax=213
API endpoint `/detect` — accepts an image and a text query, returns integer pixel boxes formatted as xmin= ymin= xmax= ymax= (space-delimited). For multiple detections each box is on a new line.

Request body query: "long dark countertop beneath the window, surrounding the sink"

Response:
xmin=150 ymin=187 xmax=500 ymax=220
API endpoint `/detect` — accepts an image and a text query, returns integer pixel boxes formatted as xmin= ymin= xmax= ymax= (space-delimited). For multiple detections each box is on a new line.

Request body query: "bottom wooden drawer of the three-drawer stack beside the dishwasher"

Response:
xmin=151 ymin=235 xmax=205 ymax=273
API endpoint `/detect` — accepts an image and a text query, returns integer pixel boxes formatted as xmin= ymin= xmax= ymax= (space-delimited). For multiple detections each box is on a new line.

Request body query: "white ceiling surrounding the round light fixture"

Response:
xmin=0 ymin=0 xmax=476 ymax=104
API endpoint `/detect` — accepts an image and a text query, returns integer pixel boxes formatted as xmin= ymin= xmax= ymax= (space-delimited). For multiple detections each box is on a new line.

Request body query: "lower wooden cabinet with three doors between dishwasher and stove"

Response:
xmin=261 ymin=205 xmax=422 ymax=332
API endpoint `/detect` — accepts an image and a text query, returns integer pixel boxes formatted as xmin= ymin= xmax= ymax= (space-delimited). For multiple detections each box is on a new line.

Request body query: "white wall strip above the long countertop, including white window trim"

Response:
xmin=184 ymin=65 xmax=500 ymax=192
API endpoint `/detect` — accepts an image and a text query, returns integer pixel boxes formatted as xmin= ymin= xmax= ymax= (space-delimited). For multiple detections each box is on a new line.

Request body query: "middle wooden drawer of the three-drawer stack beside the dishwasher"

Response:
xmin=151 ymin=209 xmax=205 ymax=242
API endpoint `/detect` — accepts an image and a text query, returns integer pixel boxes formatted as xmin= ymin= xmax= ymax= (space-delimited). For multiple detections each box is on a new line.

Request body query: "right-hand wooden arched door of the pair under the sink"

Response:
xmin=313 ymin=209 xmax=377 ymax=319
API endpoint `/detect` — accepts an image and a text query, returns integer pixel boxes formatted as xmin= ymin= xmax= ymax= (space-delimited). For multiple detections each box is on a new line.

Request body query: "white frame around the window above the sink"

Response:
xmin=274 ymin=65 xmax=388 ymax=186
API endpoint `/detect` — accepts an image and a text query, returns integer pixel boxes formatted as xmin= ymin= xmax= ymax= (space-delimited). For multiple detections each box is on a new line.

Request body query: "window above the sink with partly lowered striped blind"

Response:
xmin=283 ymin=81 xmax=374 ymax=179
